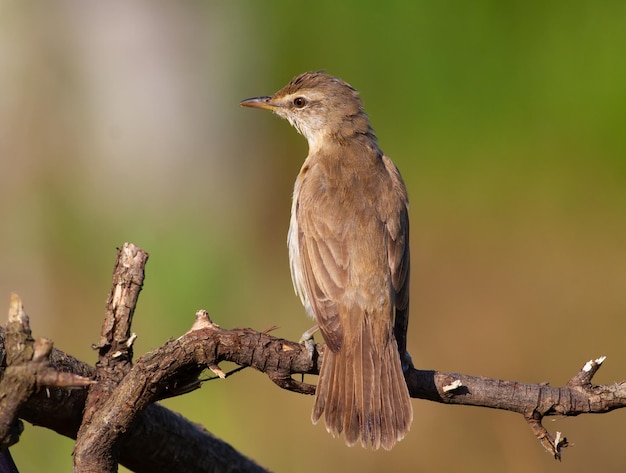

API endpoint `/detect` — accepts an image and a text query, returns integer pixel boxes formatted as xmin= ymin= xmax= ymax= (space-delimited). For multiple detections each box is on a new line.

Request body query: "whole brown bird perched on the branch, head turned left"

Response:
xmin=241 ymin=72 xmax=413 ymax=450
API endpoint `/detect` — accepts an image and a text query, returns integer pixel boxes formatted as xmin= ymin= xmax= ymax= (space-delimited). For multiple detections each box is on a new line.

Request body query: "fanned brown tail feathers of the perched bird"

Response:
xmin=311 ymin=317 xmax=413 ymax=450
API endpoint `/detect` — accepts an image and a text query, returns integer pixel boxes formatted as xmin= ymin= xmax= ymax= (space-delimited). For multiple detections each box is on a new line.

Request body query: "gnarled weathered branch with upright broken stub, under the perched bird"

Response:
xmin=0 ymin=245 xmax=626 ymax=472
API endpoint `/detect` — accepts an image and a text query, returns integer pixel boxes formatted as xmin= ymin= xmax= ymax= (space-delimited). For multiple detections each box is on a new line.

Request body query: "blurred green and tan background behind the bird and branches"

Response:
xmin=0 ymin=0 xmax=626 ymax=473
